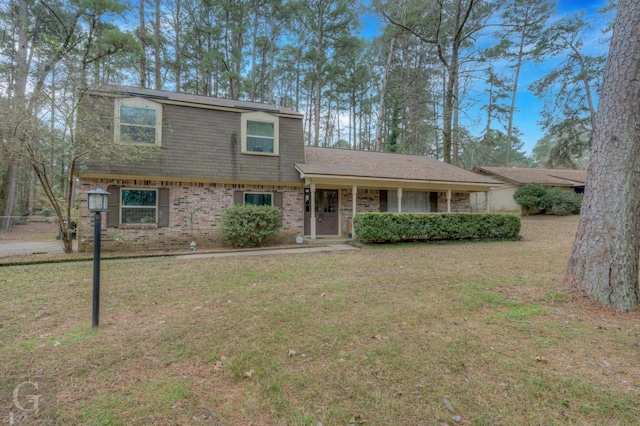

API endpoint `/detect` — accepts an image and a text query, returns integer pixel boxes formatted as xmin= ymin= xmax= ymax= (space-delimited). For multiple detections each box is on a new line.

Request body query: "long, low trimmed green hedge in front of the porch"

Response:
xmin=353 ymin=213 xmax=520 ymax=243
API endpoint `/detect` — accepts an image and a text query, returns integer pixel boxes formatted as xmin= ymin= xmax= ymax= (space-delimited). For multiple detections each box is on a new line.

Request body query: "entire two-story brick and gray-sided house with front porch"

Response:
xmin=77 ymin=87 xmax=501 ymax=250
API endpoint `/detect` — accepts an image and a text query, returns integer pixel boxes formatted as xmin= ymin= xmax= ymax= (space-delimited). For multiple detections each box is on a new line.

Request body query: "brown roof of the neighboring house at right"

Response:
xmin=473 ymin=167 xmax=587 ymax=187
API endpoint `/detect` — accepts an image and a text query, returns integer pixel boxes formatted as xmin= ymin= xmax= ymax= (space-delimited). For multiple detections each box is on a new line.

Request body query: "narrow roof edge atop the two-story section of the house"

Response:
xmin=91 ymin=86 xmax=302 ymax=118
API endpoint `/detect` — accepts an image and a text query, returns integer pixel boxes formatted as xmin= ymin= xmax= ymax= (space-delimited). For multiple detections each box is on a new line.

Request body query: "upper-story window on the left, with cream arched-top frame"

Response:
xmin=114 ymin=98 xmax=162 ymax=145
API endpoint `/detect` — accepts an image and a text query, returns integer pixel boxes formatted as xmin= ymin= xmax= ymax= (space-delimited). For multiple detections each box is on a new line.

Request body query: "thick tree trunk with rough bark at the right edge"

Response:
xmin=566 ymin=0 xmax=640 ymax=311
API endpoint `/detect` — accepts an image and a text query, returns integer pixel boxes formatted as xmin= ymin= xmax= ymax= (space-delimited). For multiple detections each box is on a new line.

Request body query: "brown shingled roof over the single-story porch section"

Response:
xmin=296 ymin=147 xmax=502 ymax=186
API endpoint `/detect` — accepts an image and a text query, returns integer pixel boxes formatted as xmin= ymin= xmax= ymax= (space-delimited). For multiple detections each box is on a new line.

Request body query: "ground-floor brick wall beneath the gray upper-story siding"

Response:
xmin=78 ymin=179 xmax=303 ymax=251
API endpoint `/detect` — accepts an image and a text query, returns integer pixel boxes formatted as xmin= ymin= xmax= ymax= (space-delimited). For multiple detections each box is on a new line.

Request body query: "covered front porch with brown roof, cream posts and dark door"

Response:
xmin=296 ymin=147 xmax=500 ymax=240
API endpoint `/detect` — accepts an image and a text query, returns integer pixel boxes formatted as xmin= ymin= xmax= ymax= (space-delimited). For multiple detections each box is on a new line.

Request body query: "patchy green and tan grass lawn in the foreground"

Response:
xmin=0 ymin=217 xmax=640 ymax=425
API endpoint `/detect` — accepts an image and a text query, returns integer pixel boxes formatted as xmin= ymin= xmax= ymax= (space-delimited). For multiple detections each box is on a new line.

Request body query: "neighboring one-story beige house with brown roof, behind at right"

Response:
xmin=472 ymin=167 xmax=587 ymax=212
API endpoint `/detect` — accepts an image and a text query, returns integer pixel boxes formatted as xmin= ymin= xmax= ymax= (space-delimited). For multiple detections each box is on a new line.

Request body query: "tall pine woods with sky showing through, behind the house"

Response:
xmin=0 ymin=0 xmax=614 ymax=226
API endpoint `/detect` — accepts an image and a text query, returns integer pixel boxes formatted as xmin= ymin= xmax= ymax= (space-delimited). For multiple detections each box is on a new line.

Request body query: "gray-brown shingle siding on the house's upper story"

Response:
xmin=83 ymin=95 xmax=304 ymax=183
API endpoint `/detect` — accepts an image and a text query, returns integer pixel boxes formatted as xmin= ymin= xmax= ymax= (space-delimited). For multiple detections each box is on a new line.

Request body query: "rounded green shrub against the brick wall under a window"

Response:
xmin=222 ymin=204 xmax=282 ymax=247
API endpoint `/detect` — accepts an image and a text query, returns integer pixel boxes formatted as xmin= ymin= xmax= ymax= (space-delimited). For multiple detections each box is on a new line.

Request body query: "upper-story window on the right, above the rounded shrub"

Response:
xmin=241 ymin=112 xmax=280 ymax=155
